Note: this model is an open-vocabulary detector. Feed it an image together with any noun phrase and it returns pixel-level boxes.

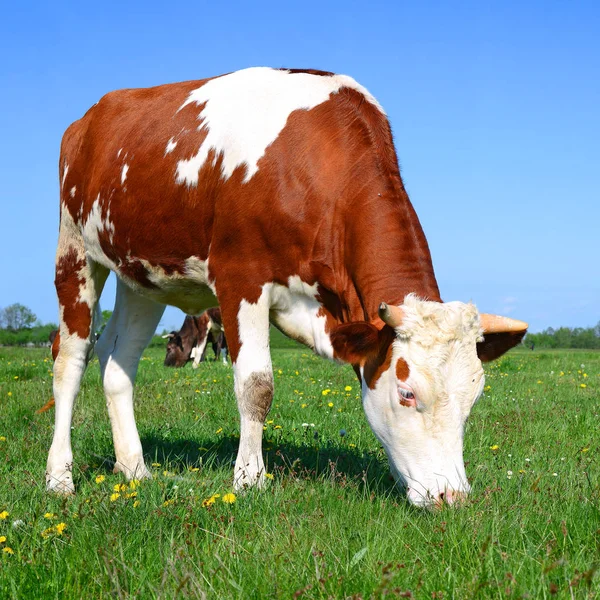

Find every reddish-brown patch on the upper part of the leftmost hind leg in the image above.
[53,247,92,346]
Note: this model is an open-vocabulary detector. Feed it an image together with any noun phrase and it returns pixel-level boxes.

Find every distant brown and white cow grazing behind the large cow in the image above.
[163,308,227,369]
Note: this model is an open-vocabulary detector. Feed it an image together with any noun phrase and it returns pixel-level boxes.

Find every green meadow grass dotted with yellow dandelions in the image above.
[0,346,600,599]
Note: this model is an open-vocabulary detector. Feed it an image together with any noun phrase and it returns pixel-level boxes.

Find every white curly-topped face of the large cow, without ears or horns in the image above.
[362,298,484,506]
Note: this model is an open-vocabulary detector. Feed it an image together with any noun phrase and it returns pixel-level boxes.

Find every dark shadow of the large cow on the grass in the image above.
[133,435,403,500]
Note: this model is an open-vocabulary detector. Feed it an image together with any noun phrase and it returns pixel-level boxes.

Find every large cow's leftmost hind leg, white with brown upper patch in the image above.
[46,230,108,494]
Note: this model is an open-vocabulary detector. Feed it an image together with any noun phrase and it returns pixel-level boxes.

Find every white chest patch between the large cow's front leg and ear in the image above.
[271,275,333,360]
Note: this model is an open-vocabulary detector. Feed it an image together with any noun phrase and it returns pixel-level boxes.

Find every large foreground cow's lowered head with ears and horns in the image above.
[331,295,527,506]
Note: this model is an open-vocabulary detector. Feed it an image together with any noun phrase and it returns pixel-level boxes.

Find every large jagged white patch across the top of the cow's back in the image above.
[176,67,382,186]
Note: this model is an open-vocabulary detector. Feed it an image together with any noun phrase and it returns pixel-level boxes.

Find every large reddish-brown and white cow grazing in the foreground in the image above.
[46,68,527,505]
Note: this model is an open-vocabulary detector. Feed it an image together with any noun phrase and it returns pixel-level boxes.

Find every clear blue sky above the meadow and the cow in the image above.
[0,0,600,331]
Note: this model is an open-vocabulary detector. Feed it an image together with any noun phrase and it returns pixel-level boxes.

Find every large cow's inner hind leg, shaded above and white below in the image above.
[96,281,165,479]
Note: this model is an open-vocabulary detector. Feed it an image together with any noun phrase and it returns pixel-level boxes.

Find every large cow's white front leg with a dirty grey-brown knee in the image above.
[222,294,273,489]
